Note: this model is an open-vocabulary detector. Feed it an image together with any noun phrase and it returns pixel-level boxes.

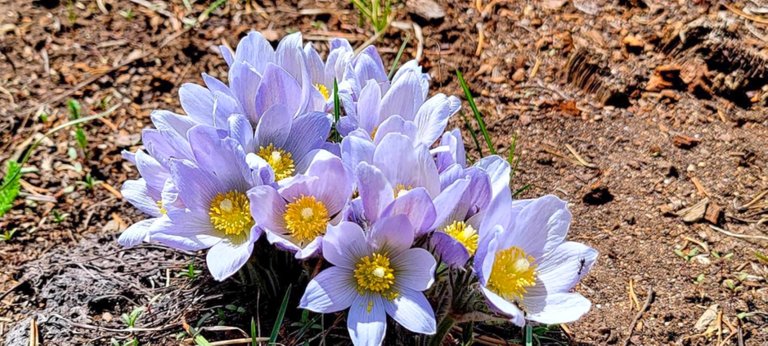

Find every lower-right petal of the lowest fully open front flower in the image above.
[384,289,437,335]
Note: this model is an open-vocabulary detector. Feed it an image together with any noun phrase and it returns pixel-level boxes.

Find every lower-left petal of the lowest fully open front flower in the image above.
[299,267,359,314]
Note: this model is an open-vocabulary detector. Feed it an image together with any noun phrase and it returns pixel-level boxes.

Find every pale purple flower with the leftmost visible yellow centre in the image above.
[150,125,272,280]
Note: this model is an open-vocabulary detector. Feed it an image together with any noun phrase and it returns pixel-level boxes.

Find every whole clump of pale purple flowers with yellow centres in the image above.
[119,32,597,345]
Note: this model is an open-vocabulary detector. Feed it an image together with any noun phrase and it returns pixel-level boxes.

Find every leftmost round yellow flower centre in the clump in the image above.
[208,191,253,236]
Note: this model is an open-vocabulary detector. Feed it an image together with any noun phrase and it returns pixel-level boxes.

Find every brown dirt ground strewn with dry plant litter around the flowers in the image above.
[0,0,768,345]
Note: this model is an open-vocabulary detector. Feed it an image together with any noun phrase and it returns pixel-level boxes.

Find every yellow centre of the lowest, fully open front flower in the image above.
[354,252,399,300]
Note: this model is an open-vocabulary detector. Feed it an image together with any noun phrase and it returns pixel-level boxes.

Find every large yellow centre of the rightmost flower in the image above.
[488,246,536,300]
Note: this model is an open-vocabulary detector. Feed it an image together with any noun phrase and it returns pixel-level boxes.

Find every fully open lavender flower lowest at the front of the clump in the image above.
[299,215,436,345]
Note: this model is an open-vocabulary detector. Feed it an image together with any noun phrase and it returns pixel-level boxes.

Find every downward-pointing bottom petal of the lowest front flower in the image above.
[347,295,387,346]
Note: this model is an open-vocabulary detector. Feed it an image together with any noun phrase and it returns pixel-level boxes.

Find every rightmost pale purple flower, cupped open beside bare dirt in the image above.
[474,194,597,326]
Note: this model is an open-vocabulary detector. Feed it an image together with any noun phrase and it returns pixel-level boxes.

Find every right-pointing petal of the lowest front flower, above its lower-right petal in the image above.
[392,248,437,292]
